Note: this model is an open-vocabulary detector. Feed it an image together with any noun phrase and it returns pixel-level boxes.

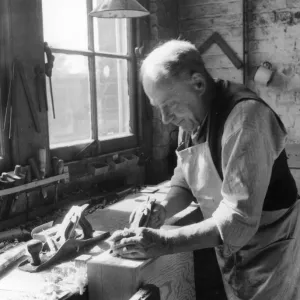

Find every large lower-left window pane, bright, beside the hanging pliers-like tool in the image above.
[47,54,91,146]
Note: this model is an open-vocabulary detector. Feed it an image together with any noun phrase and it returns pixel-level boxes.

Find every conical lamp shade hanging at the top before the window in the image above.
[89,0,150,18]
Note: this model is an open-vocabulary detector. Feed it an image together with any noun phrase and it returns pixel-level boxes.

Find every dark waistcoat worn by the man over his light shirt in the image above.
[182,81,298,211]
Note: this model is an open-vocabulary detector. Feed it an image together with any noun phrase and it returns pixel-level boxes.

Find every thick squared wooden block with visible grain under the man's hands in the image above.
[87,251,196,300]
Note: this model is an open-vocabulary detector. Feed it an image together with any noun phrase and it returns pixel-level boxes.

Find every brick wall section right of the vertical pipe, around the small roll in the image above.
[249,0,300,144]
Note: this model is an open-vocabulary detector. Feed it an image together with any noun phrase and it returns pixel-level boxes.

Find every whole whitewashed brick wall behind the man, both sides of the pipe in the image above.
[178,0,300,189]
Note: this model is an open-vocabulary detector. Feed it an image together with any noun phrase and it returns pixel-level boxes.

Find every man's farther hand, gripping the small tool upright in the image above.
[129,202,167,229]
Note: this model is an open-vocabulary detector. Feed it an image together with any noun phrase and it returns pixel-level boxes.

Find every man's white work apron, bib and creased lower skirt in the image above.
[177,142,300,300]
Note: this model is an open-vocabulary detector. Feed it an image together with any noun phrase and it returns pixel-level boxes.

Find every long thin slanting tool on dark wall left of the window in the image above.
[15,59,41,133]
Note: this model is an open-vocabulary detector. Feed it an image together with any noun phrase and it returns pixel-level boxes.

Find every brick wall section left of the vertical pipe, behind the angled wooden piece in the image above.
[178,0,243,82]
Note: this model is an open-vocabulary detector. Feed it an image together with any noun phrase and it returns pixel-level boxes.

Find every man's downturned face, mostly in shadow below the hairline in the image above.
[143,76,205,132]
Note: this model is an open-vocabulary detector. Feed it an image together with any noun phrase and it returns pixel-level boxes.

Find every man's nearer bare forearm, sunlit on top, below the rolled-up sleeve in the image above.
[167,218,222,253]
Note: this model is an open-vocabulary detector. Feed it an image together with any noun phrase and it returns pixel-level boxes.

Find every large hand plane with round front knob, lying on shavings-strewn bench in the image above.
[19,204,110,273]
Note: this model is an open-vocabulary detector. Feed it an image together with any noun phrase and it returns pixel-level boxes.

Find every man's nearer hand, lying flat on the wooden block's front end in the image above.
[108,227,172,259]
